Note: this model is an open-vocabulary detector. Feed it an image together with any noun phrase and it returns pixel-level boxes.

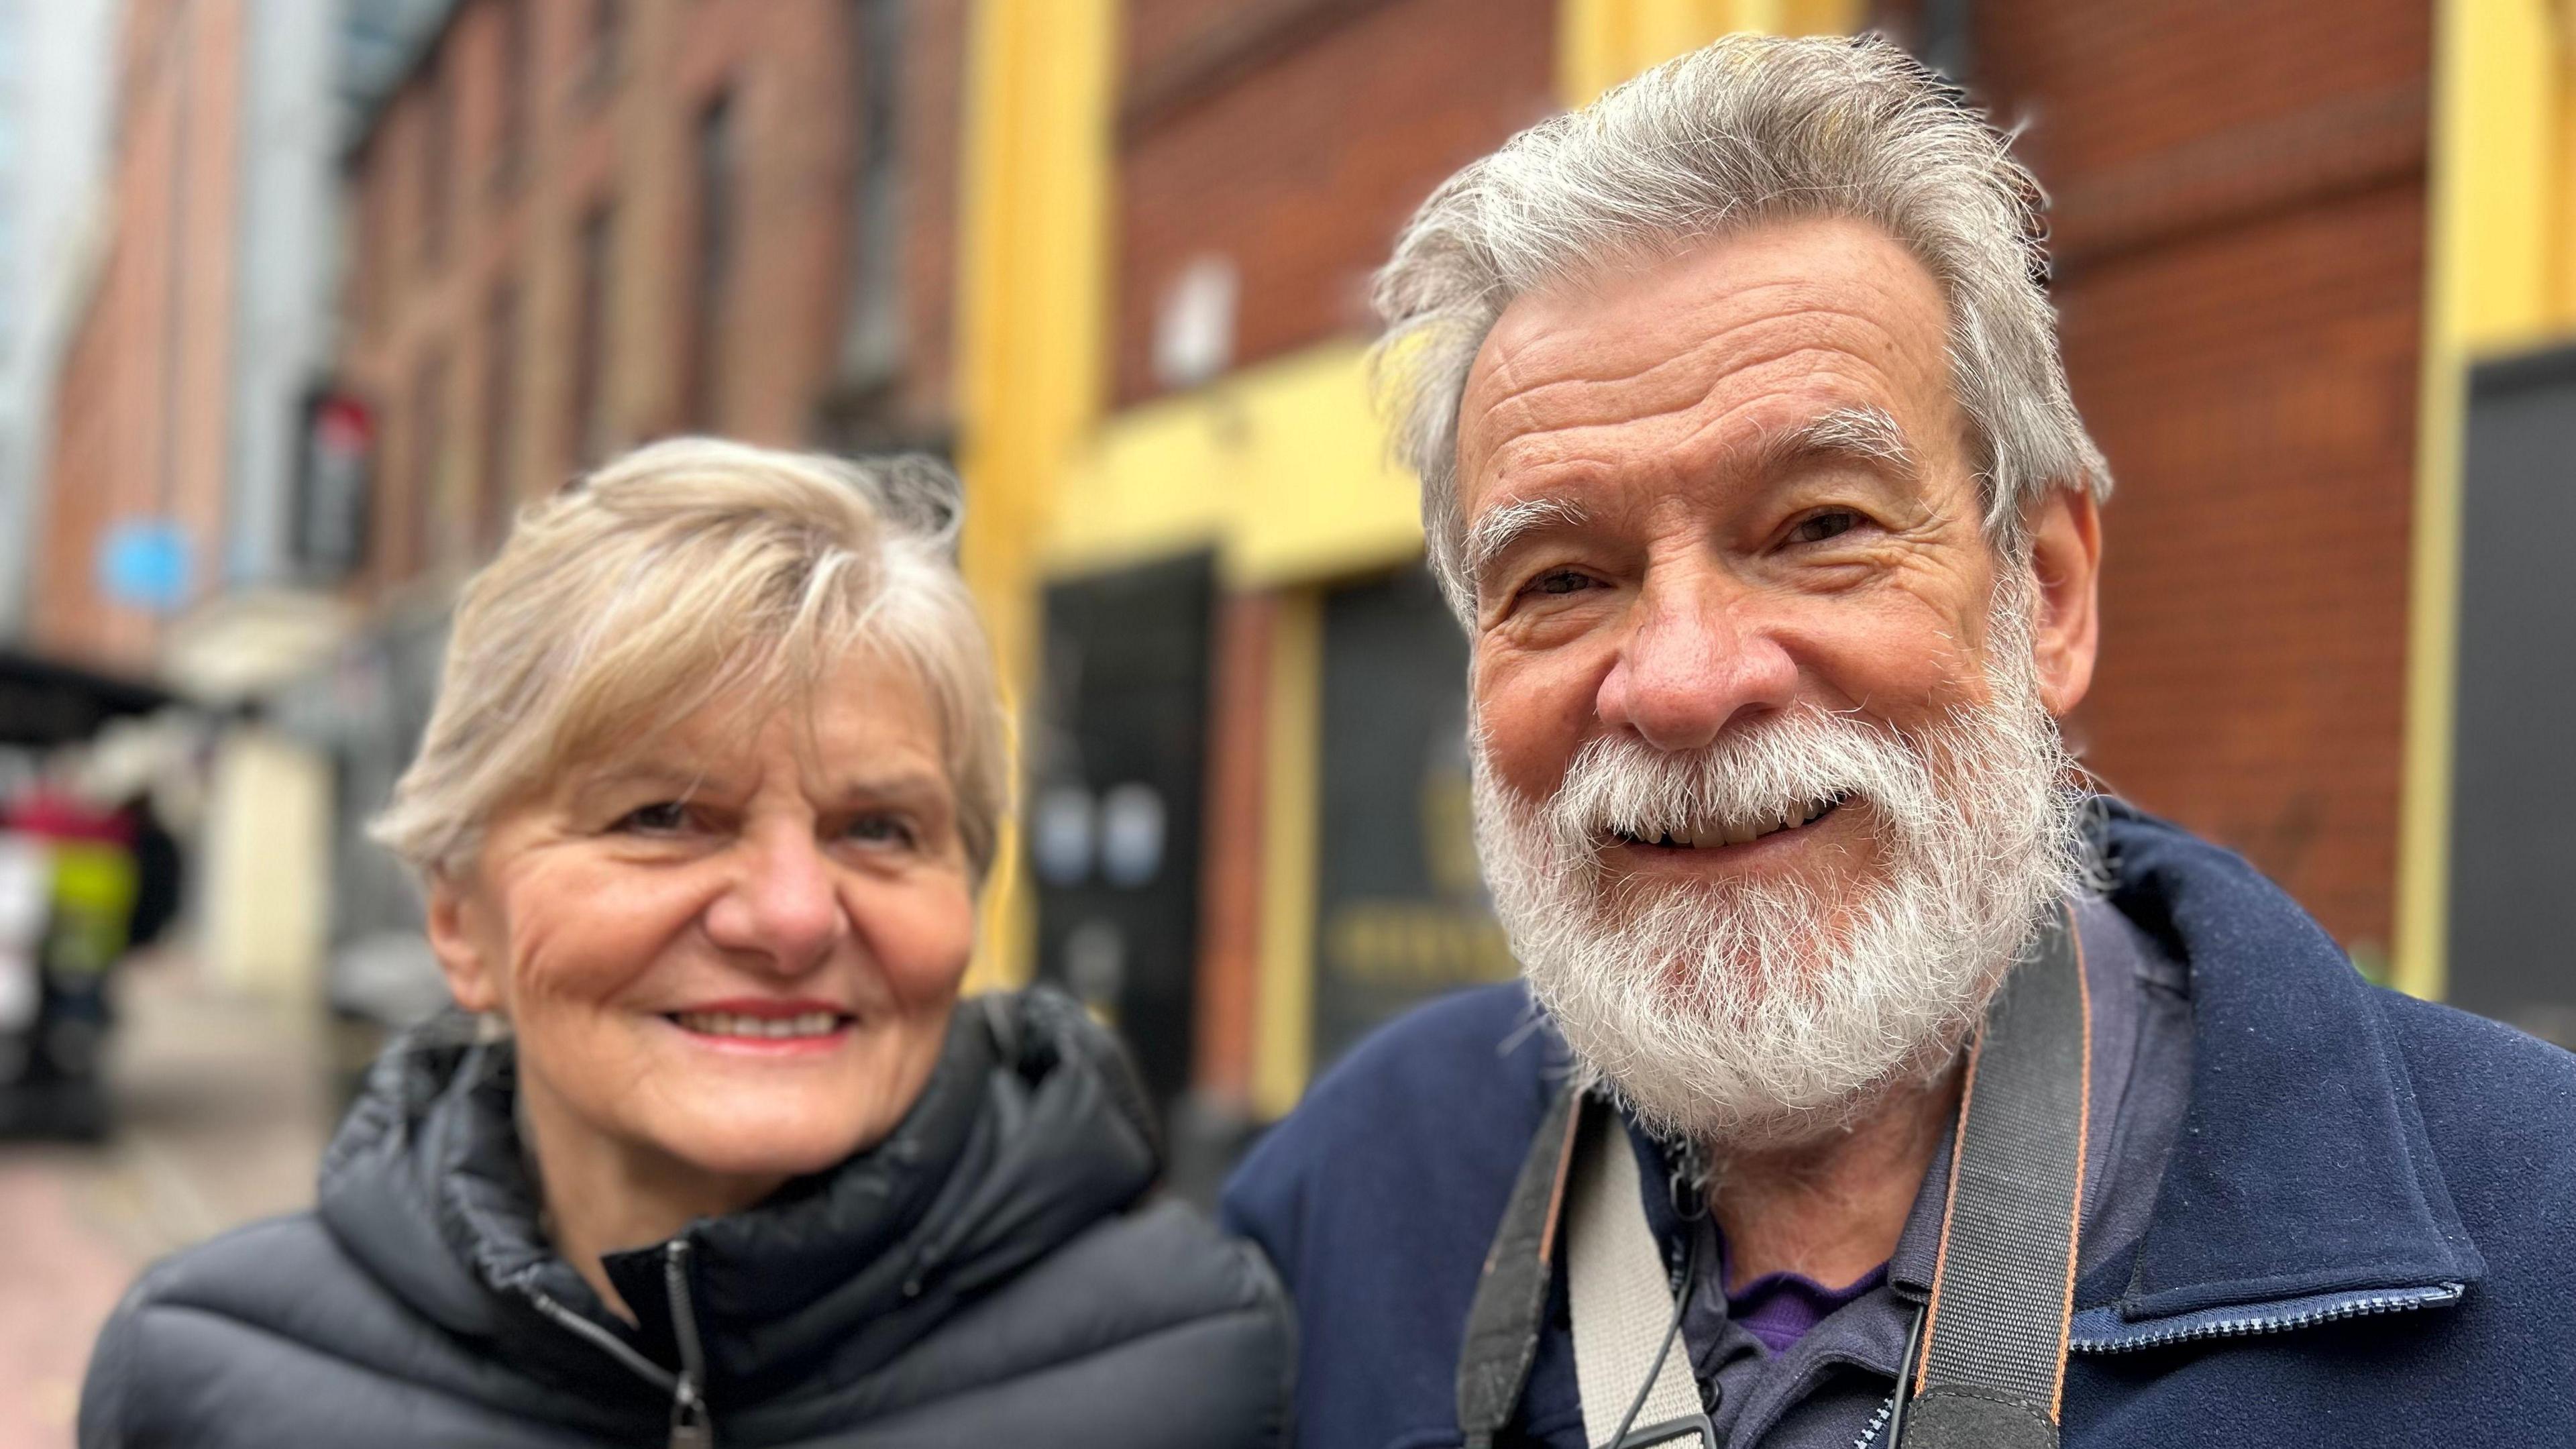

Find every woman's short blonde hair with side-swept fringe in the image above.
[374,438,1010,879]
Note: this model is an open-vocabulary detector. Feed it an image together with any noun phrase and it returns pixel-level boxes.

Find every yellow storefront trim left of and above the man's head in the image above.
[958,0,1865,1116]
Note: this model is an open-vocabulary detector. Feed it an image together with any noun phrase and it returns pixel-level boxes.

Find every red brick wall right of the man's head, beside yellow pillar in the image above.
[1973,0,2429,947]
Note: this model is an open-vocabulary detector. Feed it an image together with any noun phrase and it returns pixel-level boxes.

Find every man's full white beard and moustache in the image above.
[1473,585,2084,1150]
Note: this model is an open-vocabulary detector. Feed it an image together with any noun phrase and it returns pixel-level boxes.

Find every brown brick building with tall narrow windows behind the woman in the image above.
[301,0,969,1021]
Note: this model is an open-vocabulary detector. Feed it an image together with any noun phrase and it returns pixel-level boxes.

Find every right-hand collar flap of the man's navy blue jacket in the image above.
[2076,799,2486,1351]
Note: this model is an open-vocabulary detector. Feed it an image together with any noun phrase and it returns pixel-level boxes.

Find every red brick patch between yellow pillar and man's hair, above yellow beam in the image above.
[1113,0,1556,402]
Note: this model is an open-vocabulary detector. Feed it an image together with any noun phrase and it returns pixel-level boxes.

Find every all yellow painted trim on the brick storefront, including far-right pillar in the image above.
[958,0,2576,1116]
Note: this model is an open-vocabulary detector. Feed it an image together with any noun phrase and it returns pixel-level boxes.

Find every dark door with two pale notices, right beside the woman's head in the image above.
[1028,554,1216,1101]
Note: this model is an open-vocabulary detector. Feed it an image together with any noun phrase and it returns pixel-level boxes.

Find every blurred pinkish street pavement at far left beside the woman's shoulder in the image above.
[0,954,330,1449]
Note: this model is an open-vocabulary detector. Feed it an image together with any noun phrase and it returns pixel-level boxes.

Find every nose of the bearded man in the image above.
[1597,570,1798,750]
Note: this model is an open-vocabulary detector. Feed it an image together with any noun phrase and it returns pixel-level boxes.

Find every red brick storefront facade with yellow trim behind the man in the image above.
[961,0,2576,1134]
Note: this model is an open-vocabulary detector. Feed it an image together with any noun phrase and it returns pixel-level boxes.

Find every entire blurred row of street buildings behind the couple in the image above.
[0,0,2576,1433]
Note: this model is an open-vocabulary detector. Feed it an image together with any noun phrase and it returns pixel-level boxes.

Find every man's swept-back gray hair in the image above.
[1373,36,2110,621]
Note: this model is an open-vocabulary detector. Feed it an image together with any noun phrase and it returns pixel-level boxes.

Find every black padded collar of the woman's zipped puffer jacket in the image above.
[319,990,1159,1397]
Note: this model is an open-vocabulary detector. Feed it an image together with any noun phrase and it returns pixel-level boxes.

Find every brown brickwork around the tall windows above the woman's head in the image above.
[343,0,966,590]
